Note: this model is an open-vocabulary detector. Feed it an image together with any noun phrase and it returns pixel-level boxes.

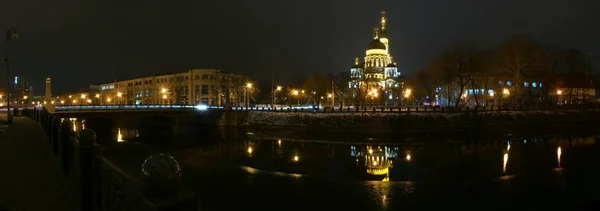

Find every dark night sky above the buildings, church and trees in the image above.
[0,0,600,93]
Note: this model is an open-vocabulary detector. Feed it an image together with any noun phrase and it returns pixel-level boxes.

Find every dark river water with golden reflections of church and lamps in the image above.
[82,120,600,210]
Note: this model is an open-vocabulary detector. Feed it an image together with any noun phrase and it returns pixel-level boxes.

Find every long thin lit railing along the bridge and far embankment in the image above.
[56,105,594,113]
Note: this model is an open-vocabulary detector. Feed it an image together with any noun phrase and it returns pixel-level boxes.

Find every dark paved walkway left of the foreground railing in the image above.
[0,115,67,211]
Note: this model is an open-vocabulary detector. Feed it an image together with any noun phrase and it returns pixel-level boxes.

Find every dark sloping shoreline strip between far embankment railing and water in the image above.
[241,111,600,137]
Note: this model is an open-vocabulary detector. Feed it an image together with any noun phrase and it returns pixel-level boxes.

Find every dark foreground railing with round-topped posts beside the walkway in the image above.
[22,109,198,211]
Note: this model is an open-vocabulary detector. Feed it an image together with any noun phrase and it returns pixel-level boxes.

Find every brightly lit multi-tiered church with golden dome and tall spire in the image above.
[349,12,403,106]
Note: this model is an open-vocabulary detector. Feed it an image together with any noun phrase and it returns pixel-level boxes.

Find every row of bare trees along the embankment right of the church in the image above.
[406,34,592,107]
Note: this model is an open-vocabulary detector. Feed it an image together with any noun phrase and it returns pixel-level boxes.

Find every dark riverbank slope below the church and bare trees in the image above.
[243,110,600,134]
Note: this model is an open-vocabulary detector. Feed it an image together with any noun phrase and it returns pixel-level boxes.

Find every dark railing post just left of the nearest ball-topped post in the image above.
[75,128,97,210]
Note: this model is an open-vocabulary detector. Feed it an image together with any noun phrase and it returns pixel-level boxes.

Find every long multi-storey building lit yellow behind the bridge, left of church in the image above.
[78,69,249,106]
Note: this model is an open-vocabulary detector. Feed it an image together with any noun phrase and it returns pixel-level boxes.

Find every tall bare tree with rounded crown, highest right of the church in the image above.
[496,34,547,104]
